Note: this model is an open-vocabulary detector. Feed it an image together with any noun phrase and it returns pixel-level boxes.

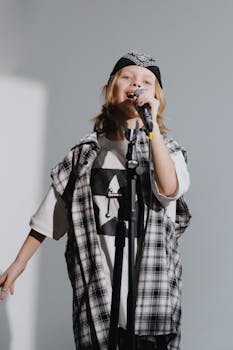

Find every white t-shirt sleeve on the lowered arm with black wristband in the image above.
[29,185,68,240]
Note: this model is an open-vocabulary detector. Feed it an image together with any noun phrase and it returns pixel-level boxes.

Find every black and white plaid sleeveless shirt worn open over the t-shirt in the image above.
[51,131,191,350]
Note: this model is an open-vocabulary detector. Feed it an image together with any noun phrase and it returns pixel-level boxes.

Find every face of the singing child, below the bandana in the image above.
[113,65,156,104]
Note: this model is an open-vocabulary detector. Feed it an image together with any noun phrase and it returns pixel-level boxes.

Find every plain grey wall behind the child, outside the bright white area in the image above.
[0,0,233,350]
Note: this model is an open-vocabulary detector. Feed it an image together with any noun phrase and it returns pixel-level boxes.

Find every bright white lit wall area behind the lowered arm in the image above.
[0,76,47,350]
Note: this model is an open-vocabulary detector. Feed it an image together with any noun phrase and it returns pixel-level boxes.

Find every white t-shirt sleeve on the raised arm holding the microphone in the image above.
[152,151,190,207]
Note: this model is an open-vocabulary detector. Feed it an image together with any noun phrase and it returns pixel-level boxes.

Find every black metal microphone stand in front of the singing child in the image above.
[108,122,139,350]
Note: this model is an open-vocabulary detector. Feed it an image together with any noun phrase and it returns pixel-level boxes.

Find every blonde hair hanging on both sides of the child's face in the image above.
[93,70,168,134]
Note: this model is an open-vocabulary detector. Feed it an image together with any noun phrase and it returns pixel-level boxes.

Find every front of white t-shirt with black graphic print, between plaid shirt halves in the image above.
[91,135,144,328]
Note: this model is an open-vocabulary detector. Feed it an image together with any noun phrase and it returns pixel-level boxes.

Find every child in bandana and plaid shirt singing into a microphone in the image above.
[0,51,191,350]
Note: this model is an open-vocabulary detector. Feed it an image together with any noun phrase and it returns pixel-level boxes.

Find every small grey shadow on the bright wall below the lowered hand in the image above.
[0,302,11,350]
